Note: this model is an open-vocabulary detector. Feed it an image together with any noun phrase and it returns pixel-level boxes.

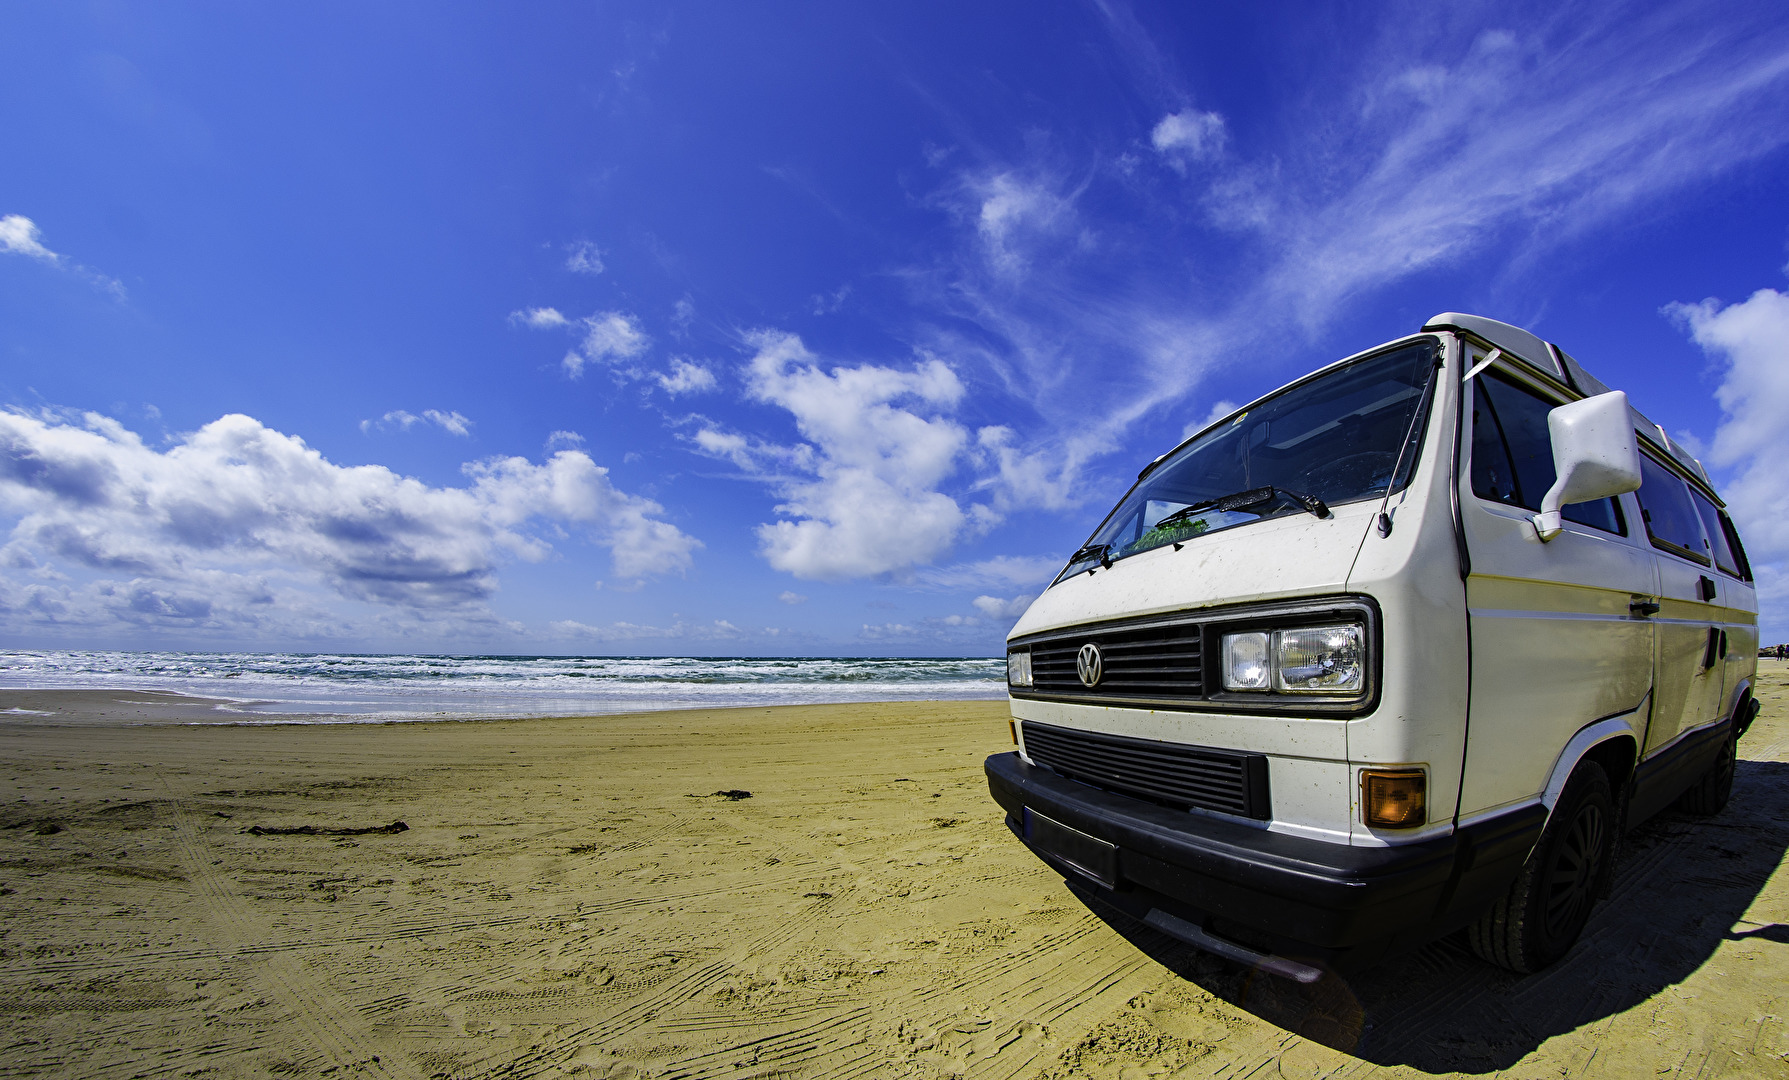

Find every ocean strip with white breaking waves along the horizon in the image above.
[0,649,1005,724]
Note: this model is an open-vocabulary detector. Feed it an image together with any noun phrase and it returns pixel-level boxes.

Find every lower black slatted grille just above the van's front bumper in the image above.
[1020,721,1270,821]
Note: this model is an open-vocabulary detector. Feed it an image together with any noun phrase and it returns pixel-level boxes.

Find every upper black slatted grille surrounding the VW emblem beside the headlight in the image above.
[1030,622,1204,697]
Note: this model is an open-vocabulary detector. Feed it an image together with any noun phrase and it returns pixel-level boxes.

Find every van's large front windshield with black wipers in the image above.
[1057,338,1438,581]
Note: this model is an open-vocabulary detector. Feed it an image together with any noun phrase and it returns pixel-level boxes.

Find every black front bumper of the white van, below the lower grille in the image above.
[986,753,1546,957]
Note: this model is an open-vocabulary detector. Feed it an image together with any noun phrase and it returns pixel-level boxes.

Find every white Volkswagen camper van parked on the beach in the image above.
[986,313,1759,982]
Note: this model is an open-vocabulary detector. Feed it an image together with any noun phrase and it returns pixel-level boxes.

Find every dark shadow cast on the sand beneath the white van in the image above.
[1075,760,1789,1073]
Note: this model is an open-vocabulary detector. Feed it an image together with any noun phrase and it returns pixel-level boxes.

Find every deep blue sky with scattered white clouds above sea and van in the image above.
[0,2,1789,654]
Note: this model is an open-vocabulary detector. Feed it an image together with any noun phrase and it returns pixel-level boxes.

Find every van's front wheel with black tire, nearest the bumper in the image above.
[1467,762,1615,975]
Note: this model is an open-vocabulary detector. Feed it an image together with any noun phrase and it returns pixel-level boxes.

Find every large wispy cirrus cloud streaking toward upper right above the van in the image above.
[911,4,1789,506]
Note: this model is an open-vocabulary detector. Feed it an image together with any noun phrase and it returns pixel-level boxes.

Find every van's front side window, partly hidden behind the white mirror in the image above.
[1472,372,1628,533]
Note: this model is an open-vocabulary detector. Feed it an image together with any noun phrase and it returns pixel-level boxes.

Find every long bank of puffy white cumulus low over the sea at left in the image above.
[0,411,699,629]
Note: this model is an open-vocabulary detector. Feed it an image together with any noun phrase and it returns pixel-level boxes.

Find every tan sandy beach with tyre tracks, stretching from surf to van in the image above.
[0,675,1789,1080]
